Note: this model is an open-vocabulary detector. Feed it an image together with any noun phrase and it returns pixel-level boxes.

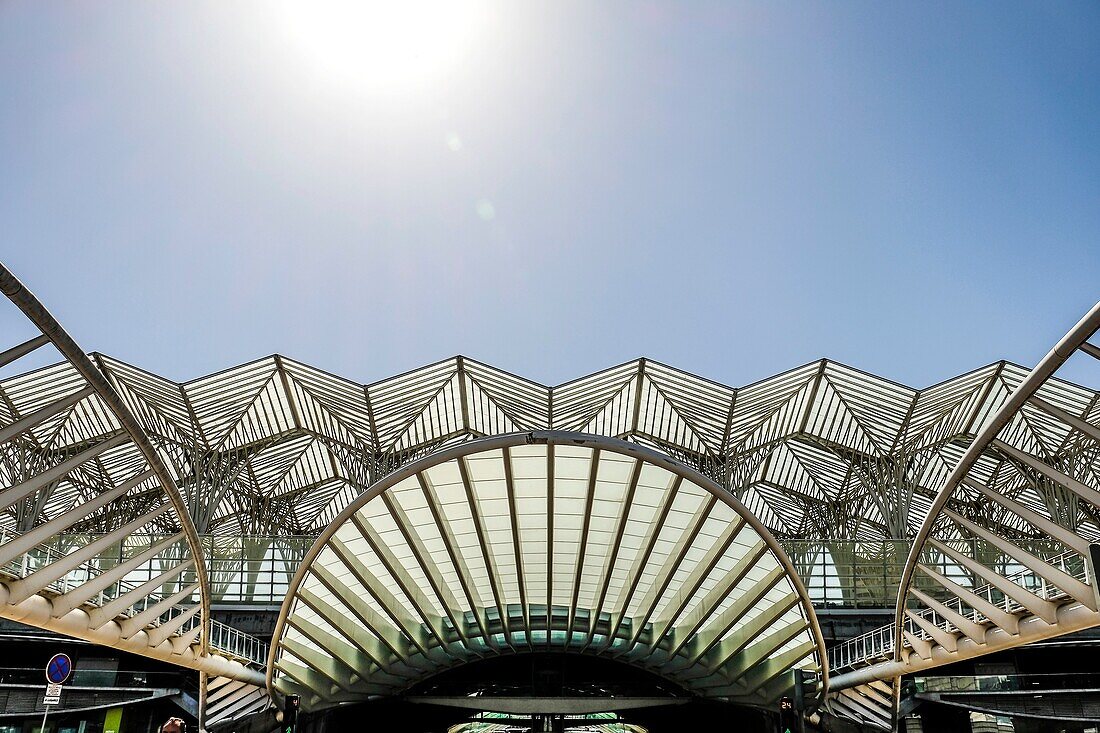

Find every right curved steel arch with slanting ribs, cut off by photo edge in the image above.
[828,304,1100,729]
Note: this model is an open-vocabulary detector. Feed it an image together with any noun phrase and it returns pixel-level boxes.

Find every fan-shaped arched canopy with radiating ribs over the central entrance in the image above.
[268,431,824,710]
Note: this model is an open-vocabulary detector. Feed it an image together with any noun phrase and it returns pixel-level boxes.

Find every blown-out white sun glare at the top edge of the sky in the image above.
[282,0,488,91]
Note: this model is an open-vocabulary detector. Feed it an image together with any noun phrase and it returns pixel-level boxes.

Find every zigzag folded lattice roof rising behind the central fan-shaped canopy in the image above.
[0,354,1097,540]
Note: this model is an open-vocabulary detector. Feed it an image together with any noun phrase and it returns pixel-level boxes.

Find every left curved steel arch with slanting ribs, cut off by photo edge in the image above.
[0,266,262,681]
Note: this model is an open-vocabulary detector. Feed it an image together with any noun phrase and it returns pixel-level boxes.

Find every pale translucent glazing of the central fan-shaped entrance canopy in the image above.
[277,434,817,703]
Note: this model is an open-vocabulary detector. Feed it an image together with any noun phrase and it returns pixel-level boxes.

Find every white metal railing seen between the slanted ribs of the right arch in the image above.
[828,550,1088,671]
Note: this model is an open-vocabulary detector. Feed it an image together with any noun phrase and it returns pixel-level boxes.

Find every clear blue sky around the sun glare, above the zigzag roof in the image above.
[0,0,1100,386]
